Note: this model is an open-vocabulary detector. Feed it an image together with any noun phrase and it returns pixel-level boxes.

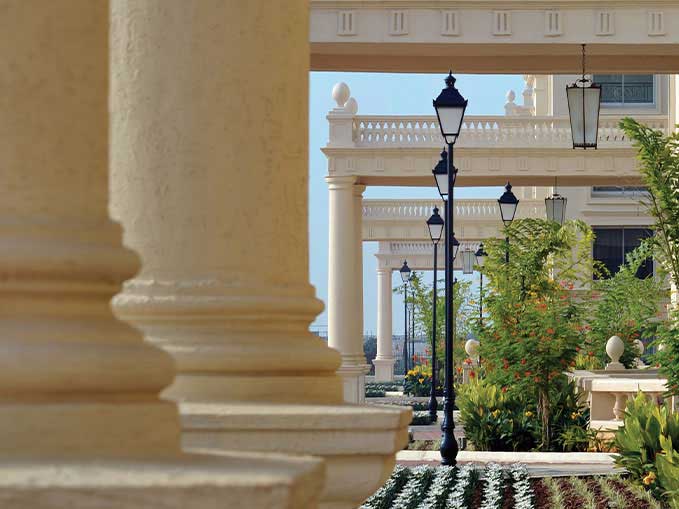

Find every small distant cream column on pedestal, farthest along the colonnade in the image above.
[373,267,396,382]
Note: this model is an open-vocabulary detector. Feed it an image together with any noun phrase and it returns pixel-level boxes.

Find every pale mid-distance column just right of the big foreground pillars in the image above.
[326,177,366,403]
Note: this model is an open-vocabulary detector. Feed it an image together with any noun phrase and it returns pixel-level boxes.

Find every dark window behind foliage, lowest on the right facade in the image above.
[593,227,653,279]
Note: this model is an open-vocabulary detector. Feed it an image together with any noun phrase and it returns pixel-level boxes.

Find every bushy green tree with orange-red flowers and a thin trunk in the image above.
[476,219,593,449]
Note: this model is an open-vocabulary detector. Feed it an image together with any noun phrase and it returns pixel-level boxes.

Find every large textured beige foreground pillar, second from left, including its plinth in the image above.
[111,0,408,508]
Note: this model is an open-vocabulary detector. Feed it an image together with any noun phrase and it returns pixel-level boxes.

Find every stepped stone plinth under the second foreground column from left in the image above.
[179,403,412,509]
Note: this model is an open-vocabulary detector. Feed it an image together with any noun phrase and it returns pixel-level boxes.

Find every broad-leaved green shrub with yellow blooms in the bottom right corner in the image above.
[614,392,679,508]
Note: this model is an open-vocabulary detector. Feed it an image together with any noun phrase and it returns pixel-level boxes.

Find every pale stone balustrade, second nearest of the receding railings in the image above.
[363,199,545,221]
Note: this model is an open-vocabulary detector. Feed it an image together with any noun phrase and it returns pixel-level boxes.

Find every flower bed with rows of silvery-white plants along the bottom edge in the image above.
[361,464,662,509]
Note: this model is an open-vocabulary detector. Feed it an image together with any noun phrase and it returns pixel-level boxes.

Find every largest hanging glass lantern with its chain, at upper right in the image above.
[566,44,601,149]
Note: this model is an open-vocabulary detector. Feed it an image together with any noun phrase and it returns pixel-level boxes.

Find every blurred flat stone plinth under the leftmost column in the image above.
[0,452,324,509]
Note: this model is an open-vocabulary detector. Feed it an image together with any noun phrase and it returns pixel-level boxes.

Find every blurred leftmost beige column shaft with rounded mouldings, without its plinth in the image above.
[0,0,179,459]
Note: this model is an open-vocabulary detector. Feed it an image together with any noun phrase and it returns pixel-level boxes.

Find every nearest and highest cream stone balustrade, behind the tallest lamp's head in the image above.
[352,115,668,148]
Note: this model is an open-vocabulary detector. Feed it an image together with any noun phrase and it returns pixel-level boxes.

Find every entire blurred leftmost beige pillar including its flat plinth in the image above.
[0,0,323,509]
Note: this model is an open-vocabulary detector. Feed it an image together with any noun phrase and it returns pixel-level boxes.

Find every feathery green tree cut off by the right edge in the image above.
[620,118,679,395]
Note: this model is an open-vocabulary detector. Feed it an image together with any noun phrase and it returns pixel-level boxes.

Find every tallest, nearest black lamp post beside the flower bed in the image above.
[433,72,467,465]
